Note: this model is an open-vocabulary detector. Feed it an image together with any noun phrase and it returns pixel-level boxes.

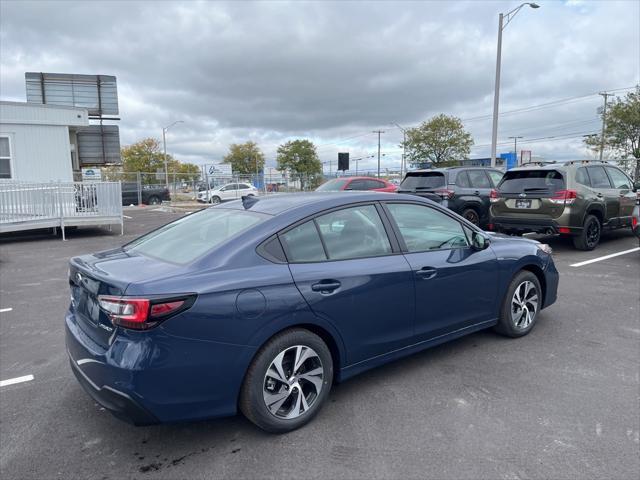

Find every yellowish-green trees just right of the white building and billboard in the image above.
[120,138,200,183]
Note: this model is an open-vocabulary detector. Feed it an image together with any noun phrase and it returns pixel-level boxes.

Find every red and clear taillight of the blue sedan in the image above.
[98,295,195,330]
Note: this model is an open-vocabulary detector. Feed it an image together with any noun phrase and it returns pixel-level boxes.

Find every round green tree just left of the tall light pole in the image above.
[400,114,473,166]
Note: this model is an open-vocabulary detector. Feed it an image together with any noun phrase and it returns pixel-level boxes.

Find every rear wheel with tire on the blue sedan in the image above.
[239,328,333,433]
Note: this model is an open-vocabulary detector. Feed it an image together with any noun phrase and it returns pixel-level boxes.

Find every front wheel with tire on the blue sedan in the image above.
[494,270,542,338]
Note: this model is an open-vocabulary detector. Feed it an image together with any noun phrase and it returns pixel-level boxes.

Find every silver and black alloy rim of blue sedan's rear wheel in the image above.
[262,345,324,419]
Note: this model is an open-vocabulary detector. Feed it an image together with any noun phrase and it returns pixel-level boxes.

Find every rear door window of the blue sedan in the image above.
[316,205,391,260]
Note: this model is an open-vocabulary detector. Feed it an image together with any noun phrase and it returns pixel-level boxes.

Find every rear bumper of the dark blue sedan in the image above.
[65,309,255,425]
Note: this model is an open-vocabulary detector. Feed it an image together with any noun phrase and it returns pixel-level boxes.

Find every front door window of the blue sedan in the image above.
[387,203,469,252]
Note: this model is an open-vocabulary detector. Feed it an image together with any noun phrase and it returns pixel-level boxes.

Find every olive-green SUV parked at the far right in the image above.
[490,160,636,250]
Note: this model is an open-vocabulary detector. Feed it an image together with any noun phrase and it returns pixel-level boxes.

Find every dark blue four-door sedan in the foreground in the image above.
[65,192,558,432]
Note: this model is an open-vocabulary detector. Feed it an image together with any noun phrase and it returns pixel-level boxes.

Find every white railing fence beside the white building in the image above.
[0,182,124,239]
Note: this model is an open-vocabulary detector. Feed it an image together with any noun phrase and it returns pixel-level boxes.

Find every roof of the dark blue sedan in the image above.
[218,191,421,215]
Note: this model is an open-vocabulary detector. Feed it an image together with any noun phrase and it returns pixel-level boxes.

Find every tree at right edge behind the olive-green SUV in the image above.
[584,89,640,182]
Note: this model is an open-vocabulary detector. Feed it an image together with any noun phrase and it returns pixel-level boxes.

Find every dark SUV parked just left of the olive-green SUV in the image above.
[398,167,503,225]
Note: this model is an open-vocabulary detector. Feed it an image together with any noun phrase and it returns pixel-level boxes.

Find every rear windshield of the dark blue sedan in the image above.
[124,207,269,265]
